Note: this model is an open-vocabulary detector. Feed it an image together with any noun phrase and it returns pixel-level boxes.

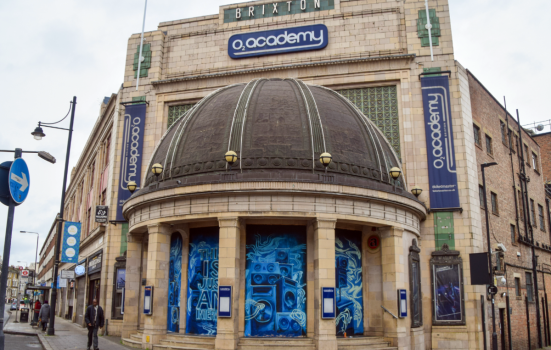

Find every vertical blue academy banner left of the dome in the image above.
[116,103,146,221]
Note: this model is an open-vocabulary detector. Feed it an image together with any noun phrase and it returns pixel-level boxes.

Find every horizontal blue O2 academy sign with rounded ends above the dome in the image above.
[228,24,329,58]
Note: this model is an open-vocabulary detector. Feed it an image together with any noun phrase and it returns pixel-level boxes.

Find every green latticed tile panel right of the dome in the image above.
[337,85,401,158]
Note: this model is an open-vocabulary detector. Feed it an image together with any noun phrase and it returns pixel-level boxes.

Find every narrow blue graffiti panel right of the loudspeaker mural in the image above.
[335,229,364,337]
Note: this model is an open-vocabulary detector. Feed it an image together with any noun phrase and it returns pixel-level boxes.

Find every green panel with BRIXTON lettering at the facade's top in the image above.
[224,0,335,23]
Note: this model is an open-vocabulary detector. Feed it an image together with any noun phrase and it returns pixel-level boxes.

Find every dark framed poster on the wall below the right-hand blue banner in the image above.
[433,264,463,321]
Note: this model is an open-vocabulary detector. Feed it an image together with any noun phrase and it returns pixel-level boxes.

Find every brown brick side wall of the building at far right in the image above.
[469,72,551,349]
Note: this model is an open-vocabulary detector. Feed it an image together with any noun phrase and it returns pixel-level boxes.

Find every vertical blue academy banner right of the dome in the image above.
[421,76,460,209]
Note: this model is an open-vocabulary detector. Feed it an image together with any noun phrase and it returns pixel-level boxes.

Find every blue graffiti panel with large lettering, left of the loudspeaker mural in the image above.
[186,227,220,336]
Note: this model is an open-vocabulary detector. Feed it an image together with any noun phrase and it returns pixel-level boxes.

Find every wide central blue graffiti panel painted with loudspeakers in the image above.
[245,225,306,337]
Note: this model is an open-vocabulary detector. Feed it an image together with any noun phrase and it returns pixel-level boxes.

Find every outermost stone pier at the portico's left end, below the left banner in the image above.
[122,233,143,338]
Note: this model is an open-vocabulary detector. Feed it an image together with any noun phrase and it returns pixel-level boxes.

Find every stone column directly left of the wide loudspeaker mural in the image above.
[215,217,241,350]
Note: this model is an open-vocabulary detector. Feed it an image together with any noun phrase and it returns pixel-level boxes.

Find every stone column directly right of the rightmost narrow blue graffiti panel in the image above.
[379,226,411,349]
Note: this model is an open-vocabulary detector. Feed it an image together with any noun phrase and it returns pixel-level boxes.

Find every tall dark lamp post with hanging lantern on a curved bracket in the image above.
[31,96,77,335]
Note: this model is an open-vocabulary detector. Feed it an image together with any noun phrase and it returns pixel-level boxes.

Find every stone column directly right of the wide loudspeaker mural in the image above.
[313,218,337,350]
